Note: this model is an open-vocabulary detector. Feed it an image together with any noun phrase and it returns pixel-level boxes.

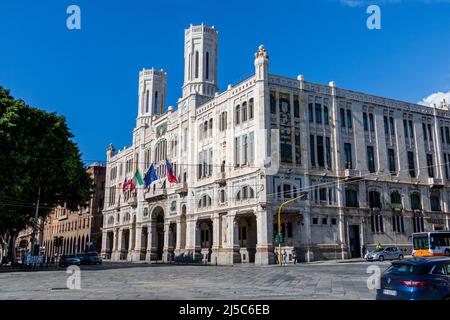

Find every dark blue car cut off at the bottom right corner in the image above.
[377,257,450,300]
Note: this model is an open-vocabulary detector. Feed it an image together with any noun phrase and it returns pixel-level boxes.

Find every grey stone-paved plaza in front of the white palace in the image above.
[0,262,390,300]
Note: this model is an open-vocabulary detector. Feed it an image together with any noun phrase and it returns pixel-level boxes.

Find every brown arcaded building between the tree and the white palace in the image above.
[41,164,106,257]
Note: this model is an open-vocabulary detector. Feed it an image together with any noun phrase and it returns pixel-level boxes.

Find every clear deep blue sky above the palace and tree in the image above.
[0,0,450,164]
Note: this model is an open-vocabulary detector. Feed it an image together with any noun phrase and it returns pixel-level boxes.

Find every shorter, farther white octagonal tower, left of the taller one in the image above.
[138,68,167,118]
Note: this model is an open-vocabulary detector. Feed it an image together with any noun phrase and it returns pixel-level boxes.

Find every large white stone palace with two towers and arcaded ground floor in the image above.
[102,24,450,264]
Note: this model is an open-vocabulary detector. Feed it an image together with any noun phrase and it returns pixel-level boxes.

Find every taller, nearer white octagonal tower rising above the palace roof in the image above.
[183,23,218,98]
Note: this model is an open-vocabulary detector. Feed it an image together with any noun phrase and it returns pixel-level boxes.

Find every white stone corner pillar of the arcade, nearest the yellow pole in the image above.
[255,210,273,264]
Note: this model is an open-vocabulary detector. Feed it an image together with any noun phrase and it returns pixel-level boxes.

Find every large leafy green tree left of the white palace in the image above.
[0,86,93,262]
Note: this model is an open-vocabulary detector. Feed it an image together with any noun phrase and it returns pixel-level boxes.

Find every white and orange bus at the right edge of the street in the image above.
[412,231,450,257]
